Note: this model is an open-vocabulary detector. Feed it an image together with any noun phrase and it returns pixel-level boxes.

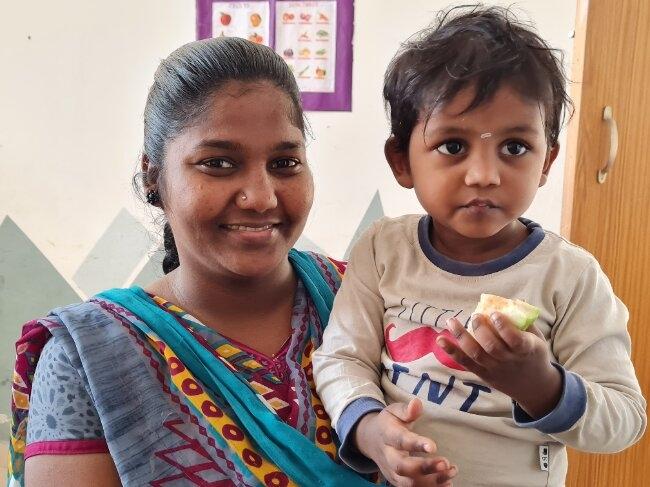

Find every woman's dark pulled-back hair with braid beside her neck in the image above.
[138,37,305,274]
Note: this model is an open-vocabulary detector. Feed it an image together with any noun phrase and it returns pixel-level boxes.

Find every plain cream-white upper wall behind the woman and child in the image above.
[0,0,575,282]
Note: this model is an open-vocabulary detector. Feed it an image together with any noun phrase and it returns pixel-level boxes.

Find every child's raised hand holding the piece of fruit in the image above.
[437,313,562,419]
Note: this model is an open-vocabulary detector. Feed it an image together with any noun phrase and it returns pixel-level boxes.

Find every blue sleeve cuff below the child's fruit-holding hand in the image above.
[512,364,587,434]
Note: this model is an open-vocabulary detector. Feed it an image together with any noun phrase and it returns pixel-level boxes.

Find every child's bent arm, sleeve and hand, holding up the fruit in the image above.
[441,258,647,453]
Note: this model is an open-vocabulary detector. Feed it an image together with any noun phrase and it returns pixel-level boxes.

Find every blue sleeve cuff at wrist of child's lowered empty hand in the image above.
[336,397,386,473]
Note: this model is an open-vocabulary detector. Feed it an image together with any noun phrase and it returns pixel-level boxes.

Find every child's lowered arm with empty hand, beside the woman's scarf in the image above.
[313,223,455,485]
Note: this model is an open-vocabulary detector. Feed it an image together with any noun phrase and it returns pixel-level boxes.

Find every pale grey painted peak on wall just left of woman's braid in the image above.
[74,209,152,296]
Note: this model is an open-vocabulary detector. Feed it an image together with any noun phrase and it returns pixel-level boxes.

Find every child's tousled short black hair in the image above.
[384,5,573,151]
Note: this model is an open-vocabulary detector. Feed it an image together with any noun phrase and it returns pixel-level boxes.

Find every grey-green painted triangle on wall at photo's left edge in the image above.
[0,216,80,440]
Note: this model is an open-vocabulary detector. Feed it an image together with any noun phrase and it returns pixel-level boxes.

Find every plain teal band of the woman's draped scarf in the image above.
[99,249,374,487]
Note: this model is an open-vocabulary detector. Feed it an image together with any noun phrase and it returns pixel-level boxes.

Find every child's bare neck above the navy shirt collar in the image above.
[429,220,529,264]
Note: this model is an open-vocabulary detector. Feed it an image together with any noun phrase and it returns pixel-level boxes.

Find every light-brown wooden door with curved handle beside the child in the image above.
[562,0,650,487]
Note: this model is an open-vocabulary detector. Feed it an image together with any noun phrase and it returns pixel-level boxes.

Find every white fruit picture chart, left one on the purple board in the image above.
[212,1,271,46]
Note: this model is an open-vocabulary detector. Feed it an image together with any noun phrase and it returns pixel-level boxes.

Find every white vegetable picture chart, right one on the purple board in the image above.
[275,1,336,93]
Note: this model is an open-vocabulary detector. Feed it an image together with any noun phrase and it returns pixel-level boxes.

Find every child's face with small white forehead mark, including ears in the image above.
[386,86,558,243]
